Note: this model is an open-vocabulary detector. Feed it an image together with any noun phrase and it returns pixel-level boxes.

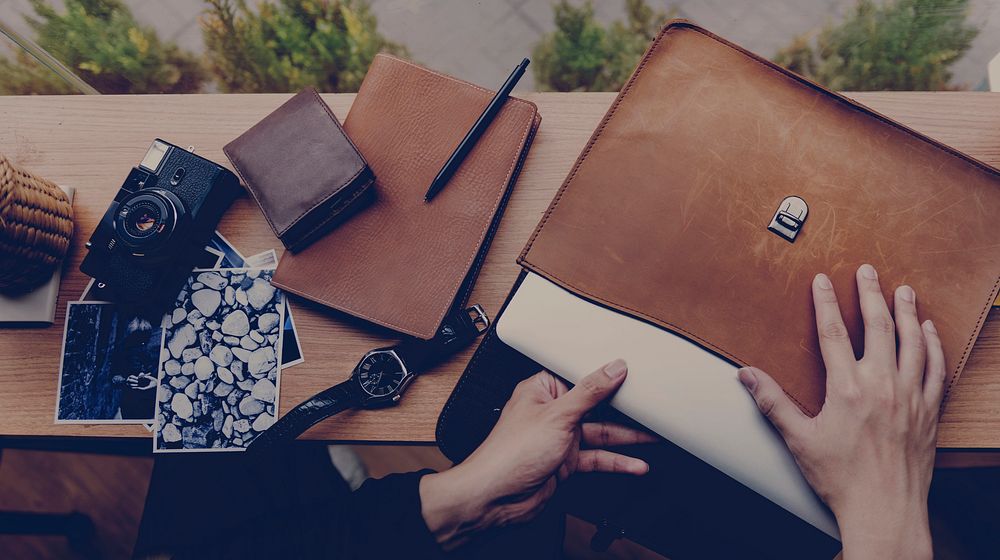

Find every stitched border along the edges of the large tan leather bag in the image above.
[517,21,1000,414]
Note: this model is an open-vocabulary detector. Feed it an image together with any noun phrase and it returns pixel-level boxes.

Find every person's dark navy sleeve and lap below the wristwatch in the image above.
[135,445,441,560]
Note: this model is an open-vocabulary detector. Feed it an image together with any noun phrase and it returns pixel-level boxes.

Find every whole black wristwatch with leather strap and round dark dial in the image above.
[248,305,490,451]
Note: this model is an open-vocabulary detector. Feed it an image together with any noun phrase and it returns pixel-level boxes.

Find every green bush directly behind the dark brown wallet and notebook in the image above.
[202,0,406,92]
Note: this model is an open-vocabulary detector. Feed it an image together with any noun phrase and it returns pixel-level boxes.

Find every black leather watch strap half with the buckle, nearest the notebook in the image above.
[394,305,490,373]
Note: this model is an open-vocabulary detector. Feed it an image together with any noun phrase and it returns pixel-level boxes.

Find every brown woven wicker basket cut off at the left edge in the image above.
[0,154,73,293]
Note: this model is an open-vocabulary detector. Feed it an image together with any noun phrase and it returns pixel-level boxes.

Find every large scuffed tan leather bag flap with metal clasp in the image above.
[519,21,1000,414]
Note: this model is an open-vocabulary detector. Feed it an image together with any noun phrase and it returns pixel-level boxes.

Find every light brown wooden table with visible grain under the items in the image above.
[0,92,1000,448]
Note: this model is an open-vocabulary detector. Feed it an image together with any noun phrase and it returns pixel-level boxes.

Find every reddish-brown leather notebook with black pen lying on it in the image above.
[273,54,541,339]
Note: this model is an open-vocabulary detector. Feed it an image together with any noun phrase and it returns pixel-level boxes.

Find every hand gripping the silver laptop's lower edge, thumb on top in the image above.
[420,360,656,548]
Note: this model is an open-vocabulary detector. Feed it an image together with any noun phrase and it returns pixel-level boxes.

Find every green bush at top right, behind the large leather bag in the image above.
[774,0,979,91]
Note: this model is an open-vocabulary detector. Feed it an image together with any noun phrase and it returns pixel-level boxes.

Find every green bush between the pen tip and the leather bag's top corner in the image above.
[533,0,675,91]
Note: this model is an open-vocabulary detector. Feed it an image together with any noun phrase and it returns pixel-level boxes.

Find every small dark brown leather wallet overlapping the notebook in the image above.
[223,88,375,252]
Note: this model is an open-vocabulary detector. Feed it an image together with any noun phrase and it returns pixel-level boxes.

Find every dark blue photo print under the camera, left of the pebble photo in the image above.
[56,302,163,424]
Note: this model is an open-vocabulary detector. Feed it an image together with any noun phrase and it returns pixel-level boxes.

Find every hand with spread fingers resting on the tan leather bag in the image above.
[739,265,945,560]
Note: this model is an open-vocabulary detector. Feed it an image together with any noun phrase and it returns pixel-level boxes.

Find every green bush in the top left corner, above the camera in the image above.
[0,0,206,95]
